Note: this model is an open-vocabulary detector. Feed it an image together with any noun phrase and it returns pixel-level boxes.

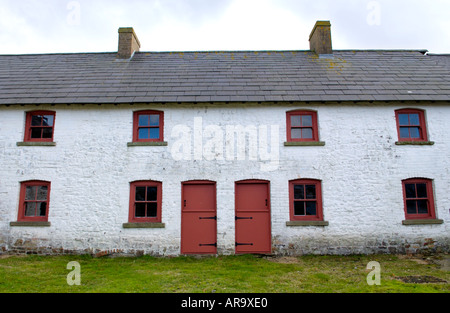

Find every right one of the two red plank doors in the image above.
[235,180,272,253]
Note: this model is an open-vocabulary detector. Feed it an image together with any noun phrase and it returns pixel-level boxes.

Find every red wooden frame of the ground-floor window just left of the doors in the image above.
[128,180,162,223]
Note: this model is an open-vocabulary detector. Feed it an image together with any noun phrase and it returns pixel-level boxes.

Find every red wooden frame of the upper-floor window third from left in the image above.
[286,110,319,142]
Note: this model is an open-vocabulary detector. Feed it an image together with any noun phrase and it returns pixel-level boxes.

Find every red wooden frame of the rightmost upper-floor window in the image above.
[395,109,428,141]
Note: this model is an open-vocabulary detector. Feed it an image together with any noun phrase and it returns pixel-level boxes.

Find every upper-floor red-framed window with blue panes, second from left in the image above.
[133,111,164,142]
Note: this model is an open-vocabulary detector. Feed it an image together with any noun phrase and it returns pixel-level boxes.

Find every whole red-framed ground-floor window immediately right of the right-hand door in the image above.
[289,179,323,221]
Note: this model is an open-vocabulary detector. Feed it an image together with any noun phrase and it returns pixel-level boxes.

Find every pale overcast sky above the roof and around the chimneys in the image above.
[0,0,450,54]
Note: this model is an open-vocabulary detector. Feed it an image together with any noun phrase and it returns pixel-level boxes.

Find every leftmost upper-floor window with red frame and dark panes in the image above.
[24,111,55,141]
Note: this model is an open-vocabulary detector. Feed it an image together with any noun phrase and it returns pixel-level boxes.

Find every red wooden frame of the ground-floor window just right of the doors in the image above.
[289,179,323,221]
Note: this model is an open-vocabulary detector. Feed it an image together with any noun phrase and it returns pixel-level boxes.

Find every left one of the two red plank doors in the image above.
[181,181,217,254]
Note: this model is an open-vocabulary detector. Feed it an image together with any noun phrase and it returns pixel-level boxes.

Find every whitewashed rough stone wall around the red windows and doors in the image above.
[0,103,450,255]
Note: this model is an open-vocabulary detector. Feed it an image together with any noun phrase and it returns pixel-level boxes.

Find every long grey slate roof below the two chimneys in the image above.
[0,50,450,105]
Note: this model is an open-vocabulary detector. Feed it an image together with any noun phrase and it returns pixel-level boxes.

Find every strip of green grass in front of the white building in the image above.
[0,255,450,293]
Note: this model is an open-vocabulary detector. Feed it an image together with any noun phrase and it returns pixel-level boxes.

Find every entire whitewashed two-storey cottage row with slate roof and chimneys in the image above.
[0,22,450,256]
